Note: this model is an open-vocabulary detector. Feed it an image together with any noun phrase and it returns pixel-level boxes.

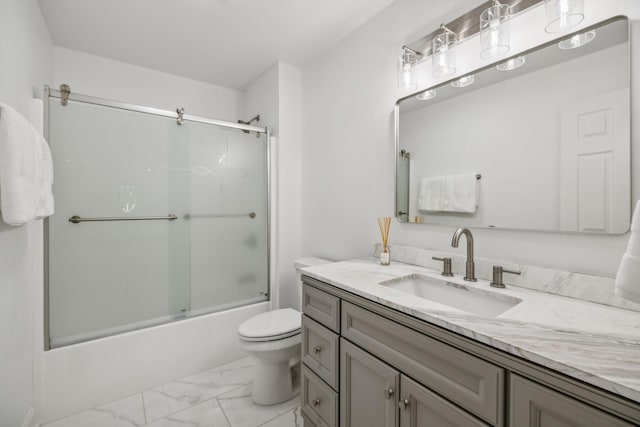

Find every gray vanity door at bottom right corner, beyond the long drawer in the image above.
[509,375,633,427]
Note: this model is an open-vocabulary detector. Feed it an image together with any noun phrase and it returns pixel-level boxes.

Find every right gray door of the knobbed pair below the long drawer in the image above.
[399,375,488,427]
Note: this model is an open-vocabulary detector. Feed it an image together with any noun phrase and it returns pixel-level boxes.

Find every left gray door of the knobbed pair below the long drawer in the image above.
[340,338,400,427]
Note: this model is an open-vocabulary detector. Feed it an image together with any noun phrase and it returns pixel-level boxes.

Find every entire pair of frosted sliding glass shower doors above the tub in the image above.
[45,95,269,347]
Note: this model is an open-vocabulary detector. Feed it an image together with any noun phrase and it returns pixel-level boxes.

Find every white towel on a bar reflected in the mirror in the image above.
[418,174,478,213]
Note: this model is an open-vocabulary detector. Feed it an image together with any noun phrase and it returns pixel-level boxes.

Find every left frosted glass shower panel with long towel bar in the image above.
[48,98,191,347]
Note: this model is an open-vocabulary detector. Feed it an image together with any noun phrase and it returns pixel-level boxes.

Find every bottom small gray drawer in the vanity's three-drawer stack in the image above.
[301,364,338,427]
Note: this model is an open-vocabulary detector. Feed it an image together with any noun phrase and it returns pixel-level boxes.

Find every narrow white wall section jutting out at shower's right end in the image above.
[245,62,301,308]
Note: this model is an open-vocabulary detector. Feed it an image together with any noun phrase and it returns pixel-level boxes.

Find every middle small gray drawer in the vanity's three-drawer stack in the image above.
[302,315,339,389]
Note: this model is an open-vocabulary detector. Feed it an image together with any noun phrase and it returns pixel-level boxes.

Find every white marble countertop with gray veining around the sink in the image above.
[302,258,640,403]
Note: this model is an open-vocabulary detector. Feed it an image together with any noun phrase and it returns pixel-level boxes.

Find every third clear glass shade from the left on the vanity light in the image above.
[480,2,511,59]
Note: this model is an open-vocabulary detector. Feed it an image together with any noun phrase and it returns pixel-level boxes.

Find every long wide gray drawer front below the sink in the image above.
[342,301,504,426]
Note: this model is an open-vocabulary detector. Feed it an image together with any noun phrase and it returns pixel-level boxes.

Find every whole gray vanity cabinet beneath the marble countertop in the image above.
[302,276,640,427]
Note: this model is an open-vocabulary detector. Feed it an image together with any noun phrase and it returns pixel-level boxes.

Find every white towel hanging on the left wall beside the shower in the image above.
[0,104,54,225]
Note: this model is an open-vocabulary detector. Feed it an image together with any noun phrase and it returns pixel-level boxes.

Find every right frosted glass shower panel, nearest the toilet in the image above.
[188,123,269,313]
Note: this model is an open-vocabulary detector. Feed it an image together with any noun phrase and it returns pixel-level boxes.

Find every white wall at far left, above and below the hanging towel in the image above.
[0,0,53,426]
